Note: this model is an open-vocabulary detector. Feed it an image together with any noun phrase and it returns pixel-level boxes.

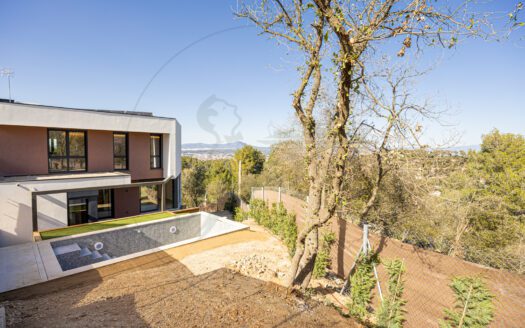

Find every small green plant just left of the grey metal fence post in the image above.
[348,254,379,322]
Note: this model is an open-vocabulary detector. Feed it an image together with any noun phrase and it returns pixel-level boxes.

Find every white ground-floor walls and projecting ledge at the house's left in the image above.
[0,175,131,247]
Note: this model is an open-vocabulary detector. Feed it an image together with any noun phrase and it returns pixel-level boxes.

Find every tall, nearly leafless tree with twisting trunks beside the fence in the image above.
[236,0,521,287]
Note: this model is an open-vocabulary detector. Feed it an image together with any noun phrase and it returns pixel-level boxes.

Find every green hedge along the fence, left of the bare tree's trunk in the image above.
[244,199,297,254]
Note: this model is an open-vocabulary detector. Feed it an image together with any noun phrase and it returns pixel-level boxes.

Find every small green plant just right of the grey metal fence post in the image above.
[376,259,406,328]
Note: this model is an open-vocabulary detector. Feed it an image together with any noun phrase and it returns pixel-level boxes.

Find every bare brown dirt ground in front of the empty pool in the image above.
[0,219,358,327]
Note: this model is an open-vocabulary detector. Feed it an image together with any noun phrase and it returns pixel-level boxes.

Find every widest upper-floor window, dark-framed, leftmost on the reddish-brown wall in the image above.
[47,130,87,173]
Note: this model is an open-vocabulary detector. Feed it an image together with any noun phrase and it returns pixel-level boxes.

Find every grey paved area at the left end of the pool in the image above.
[0,243,48,293]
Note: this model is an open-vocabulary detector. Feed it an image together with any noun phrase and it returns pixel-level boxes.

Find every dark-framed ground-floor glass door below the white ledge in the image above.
[67,189,113,225]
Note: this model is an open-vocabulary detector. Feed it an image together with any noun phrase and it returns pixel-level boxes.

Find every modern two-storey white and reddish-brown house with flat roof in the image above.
[0,100,181,247]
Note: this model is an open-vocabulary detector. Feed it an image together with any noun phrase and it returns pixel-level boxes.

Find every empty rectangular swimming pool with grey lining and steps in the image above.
[49,212,248,272]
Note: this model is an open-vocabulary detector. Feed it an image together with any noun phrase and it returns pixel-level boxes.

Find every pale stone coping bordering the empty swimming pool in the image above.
[36,212,249,281]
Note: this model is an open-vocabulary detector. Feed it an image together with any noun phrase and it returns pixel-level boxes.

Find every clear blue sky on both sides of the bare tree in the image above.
[0,0,525,145]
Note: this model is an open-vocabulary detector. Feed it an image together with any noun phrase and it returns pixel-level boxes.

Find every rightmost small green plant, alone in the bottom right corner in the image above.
[439,277,494,328]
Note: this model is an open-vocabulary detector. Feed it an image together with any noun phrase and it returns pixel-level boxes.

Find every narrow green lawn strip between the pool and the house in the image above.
[40,212,177,240]
